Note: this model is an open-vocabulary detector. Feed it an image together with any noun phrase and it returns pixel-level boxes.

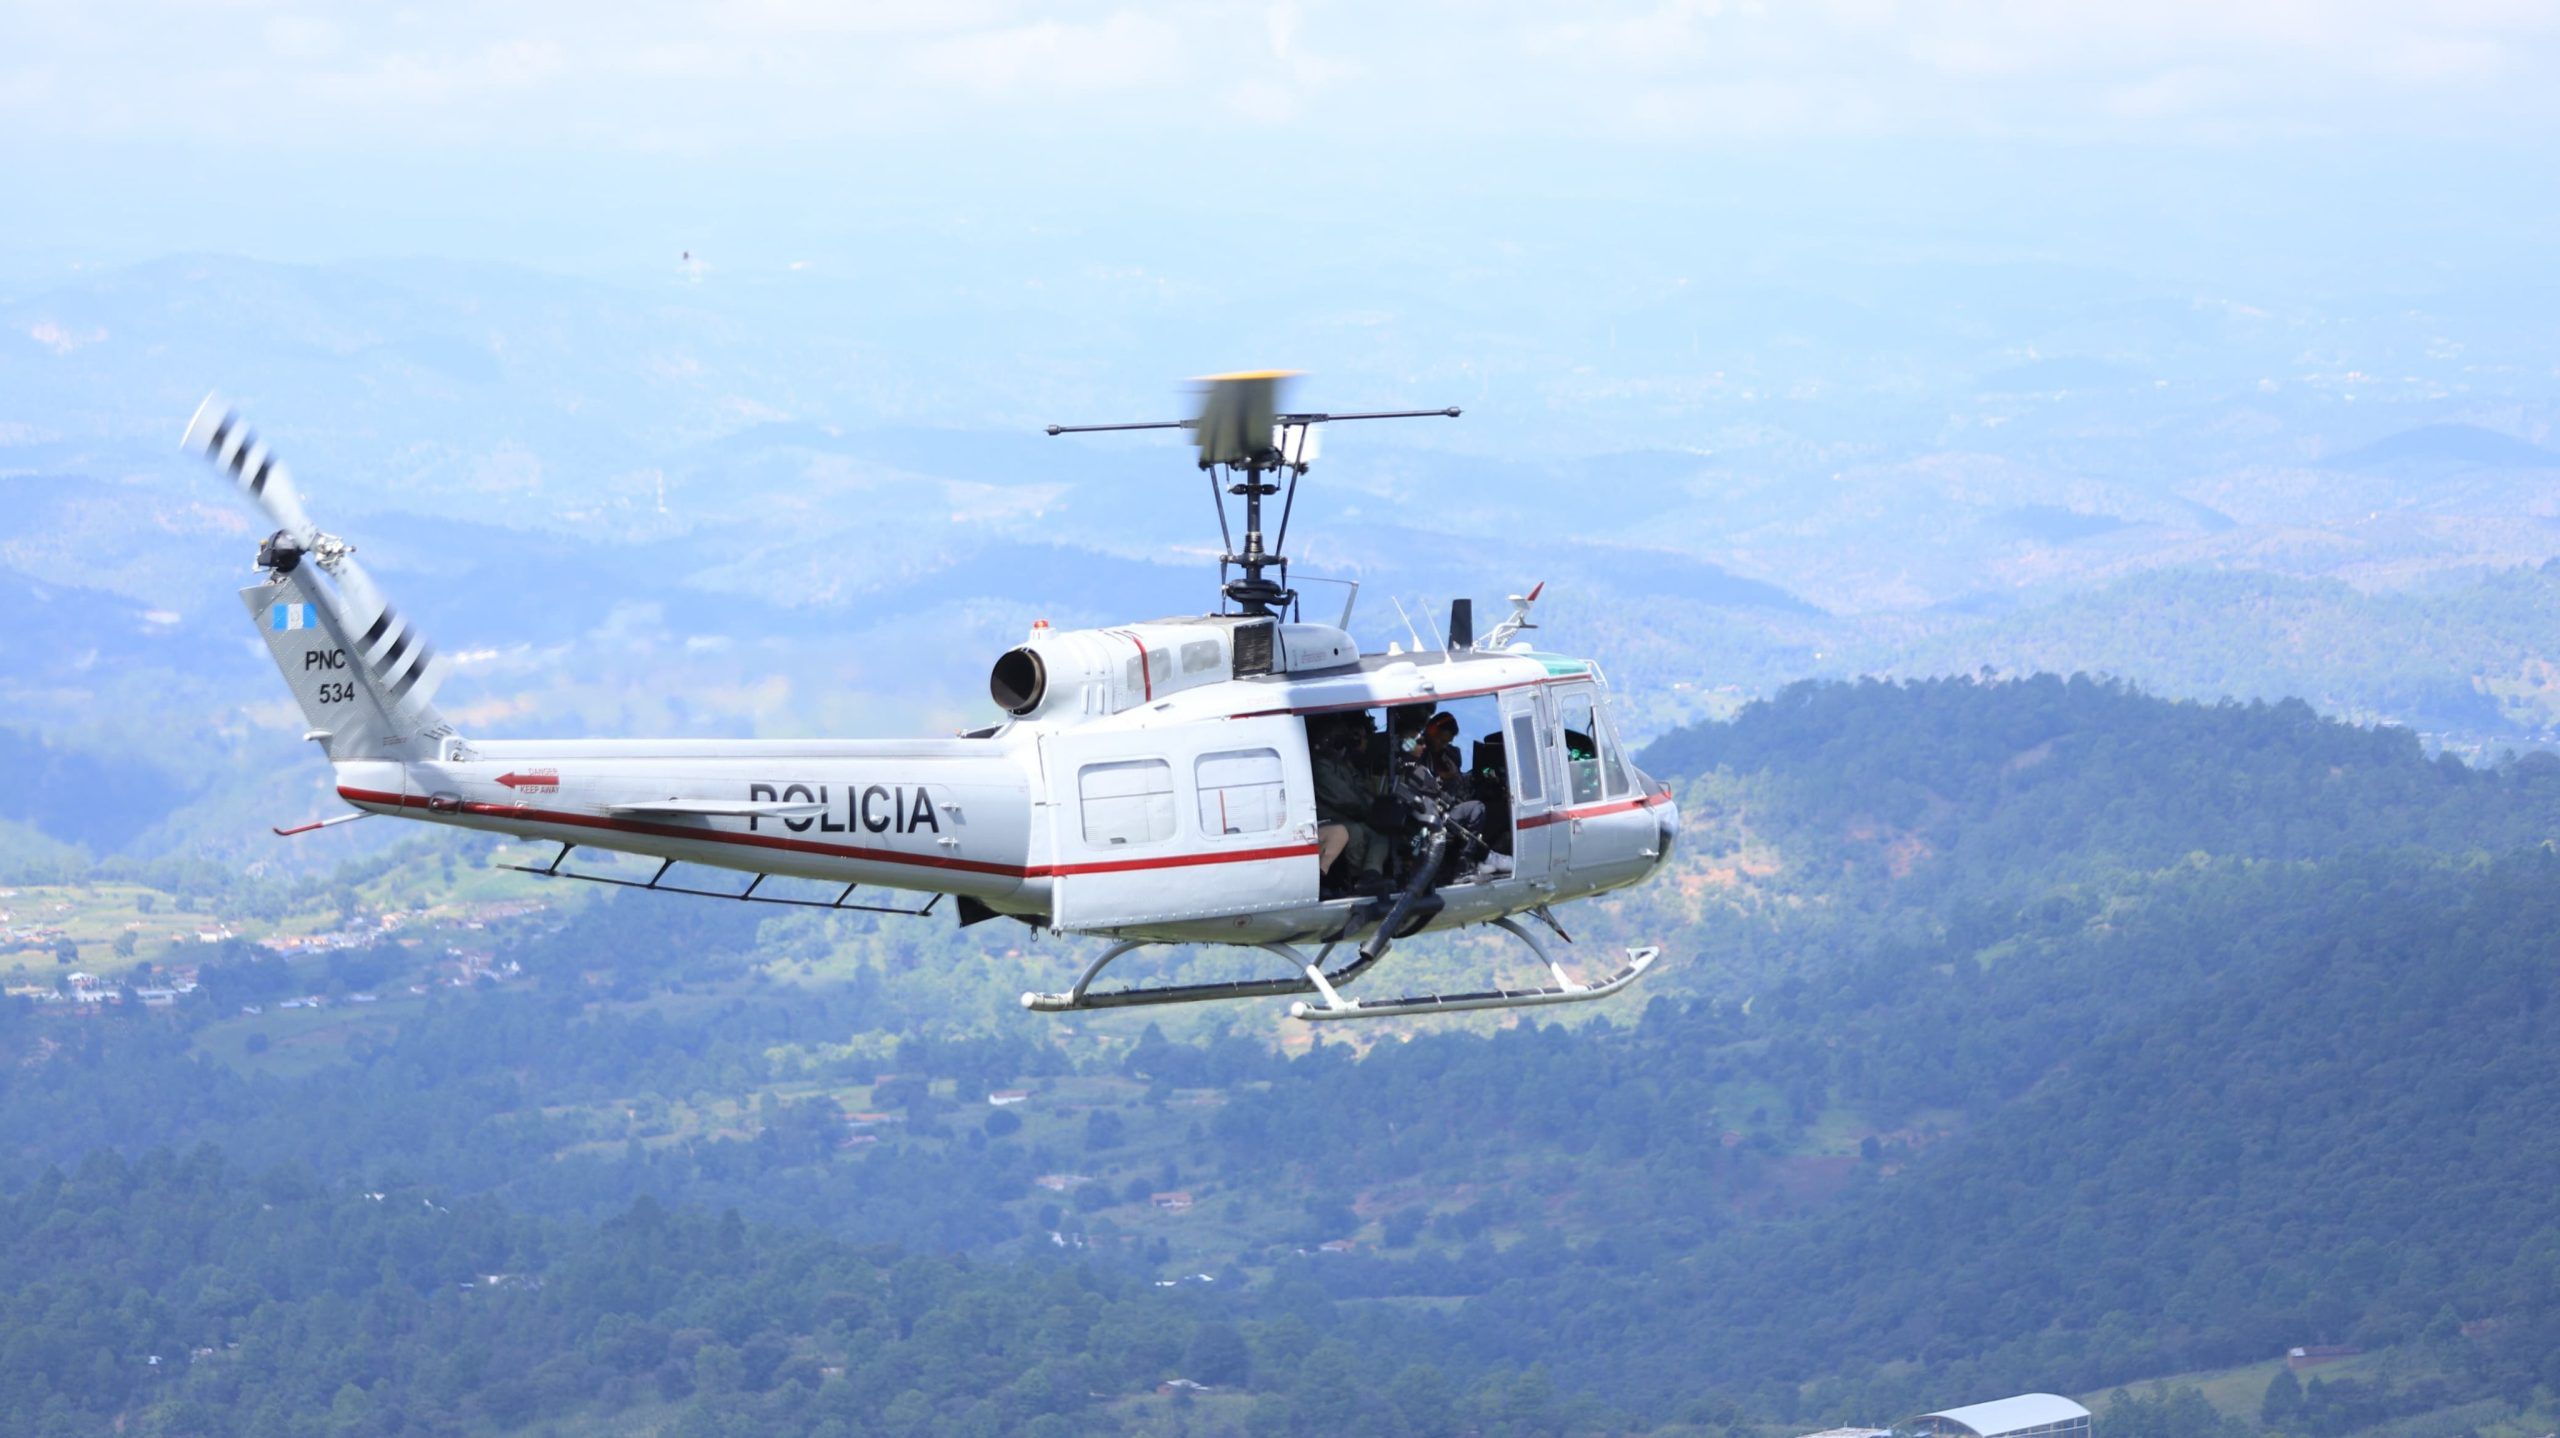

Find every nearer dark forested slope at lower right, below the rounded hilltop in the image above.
[1423,852,2560,1415]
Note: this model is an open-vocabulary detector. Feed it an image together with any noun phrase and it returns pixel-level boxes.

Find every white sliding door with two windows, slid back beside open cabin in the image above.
[1042,714,1316,929]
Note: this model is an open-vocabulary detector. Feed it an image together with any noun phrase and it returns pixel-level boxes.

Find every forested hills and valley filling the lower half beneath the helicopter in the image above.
[0,678,2560,1438]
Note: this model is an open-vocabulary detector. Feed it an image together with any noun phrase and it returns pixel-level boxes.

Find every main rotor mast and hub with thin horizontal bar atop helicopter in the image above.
[1050,368,1459,617]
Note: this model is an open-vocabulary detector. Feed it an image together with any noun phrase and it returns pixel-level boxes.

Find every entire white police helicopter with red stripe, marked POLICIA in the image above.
[184,371,1679,1021]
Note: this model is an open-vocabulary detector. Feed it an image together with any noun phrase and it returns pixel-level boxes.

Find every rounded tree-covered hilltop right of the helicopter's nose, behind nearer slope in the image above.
[1638,676,2560,898]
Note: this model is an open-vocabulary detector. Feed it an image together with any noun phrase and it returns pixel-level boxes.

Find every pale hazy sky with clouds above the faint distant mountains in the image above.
[0,0,2560,279]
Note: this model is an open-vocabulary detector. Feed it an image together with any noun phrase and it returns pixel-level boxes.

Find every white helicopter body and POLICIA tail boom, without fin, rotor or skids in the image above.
[338,637,1679,944]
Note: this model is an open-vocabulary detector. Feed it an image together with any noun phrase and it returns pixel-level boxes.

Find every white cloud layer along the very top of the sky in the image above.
[0,0,2560,154]
